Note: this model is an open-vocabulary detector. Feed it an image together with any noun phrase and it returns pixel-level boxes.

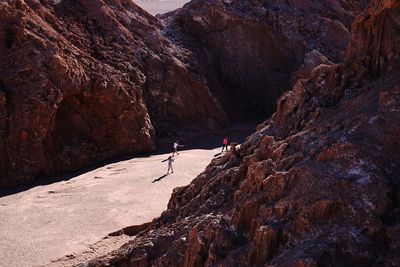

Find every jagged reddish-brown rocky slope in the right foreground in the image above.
[84,0,400,266]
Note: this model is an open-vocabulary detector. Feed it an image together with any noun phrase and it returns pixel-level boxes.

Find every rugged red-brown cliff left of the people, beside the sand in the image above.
[0,0,227,187]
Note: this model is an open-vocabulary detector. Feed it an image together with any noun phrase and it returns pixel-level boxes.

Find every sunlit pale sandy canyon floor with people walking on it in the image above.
[0,148,220,267]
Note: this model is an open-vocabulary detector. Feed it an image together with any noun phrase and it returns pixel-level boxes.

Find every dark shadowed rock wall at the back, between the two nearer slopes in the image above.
[162,0,359,120]
